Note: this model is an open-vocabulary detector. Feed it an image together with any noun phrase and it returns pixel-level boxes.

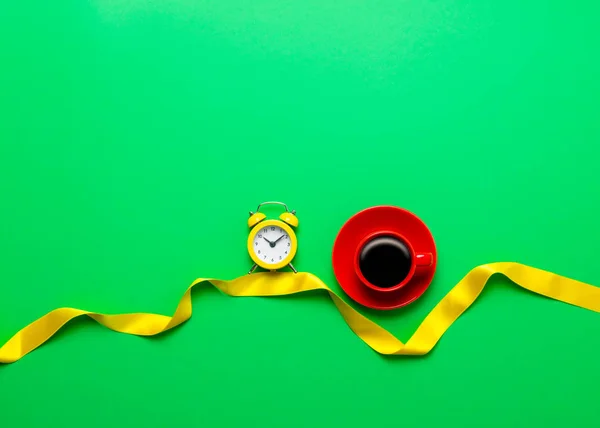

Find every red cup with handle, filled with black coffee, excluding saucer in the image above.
[355,232,432,291]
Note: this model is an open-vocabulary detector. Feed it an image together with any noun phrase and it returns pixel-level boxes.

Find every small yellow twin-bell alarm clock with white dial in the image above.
[248,202,298,273]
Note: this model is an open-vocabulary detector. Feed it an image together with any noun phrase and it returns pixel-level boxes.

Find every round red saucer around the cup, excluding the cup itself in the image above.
[333,206,437,310]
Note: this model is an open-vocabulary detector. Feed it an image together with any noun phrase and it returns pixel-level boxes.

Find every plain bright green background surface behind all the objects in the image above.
[0,0,600,428]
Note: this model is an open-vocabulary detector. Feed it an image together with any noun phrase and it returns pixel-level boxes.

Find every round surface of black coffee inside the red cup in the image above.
[358,236,411,288]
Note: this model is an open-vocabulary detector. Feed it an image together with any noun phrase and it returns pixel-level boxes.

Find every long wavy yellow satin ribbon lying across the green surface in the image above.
[0,263,600,364]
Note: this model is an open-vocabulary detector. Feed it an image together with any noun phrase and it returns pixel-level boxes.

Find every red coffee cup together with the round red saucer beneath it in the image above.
[332,205,437,310]
